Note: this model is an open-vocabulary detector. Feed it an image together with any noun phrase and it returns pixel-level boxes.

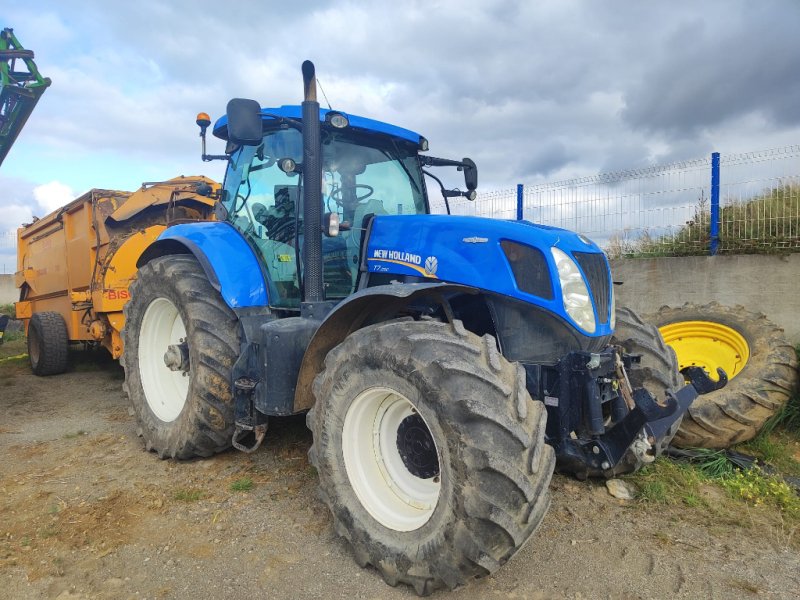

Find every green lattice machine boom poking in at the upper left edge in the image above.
[0,28,51,165]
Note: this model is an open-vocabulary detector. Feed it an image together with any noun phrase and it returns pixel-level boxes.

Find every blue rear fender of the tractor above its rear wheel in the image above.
[158,222,267,308]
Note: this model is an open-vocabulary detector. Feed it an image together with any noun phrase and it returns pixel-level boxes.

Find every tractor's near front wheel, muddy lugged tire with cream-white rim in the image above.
[307,321,555,595]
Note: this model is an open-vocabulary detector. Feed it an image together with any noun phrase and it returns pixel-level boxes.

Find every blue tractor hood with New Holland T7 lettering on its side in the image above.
[367,215,612,337]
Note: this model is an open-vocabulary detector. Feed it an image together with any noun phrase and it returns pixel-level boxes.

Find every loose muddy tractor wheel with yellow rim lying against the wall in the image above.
[651,302,798,448]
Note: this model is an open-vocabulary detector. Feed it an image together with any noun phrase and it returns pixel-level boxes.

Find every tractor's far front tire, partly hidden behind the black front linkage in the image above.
[611,308,684,460]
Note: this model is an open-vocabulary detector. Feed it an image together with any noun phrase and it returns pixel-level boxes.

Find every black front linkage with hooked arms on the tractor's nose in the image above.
[526,346,725,479]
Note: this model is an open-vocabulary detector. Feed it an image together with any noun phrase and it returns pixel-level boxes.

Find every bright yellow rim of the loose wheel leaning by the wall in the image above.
[658,321,750,381]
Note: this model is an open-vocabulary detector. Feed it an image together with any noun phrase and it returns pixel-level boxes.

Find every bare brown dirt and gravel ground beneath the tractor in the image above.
[0,350,800,600]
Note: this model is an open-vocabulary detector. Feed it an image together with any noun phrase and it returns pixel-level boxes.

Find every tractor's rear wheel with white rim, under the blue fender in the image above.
[120,254,239,459]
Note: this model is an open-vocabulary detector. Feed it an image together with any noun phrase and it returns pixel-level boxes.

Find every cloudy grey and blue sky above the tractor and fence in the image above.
[0,0,800,272]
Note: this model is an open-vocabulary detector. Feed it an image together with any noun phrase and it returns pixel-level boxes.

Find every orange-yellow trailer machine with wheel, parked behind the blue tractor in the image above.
[15,177,219,375]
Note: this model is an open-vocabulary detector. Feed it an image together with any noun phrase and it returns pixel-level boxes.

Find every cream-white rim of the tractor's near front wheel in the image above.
[342,388,441,531]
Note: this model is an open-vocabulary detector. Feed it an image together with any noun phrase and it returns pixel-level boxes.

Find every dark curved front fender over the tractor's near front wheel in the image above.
[294,283,479,412]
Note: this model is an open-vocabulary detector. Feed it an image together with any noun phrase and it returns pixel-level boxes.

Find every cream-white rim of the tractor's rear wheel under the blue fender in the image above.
[139,298,190,423]
